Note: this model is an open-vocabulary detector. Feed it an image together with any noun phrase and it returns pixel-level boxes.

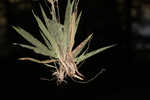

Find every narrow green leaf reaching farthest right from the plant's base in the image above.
[75,45,115,64]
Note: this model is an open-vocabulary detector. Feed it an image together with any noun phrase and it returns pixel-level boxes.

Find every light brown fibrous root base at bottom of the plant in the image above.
[53,53,84,84]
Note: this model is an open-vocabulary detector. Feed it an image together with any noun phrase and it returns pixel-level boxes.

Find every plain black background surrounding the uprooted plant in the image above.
[0,0,150,100]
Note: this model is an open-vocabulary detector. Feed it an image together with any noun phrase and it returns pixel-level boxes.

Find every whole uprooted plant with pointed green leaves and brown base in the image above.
[13,0,114,83]
